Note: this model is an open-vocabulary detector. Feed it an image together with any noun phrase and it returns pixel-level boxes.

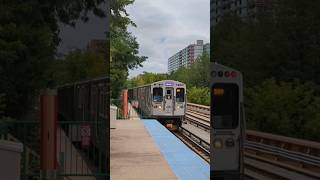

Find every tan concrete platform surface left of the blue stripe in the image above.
[110,117,177,180]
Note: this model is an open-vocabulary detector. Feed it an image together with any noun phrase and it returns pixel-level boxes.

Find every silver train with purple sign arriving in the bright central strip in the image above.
[128,80,187,127]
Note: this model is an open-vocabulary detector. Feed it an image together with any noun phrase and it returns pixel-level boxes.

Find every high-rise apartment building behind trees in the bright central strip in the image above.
[168,40,210,73]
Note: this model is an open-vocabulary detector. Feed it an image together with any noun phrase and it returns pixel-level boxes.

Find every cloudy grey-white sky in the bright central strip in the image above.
[127,0,210,78]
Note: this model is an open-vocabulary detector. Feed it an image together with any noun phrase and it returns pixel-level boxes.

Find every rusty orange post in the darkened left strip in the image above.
[40,89,58,180]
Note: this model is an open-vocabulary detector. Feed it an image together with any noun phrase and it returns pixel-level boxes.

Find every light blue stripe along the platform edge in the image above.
[143,119,210,180]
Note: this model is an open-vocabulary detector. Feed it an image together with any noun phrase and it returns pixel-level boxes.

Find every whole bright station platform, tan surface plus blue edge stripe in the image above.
[110,104,210,180]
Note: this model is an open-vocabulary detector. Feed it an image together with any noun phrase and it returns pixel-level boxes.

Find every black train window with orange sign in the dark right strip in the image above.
[210,83,239,129]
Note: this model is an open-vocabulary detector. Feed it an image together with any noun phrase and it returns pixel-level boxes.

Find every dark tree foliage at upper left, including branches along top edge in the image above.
[0,0,105,118]
